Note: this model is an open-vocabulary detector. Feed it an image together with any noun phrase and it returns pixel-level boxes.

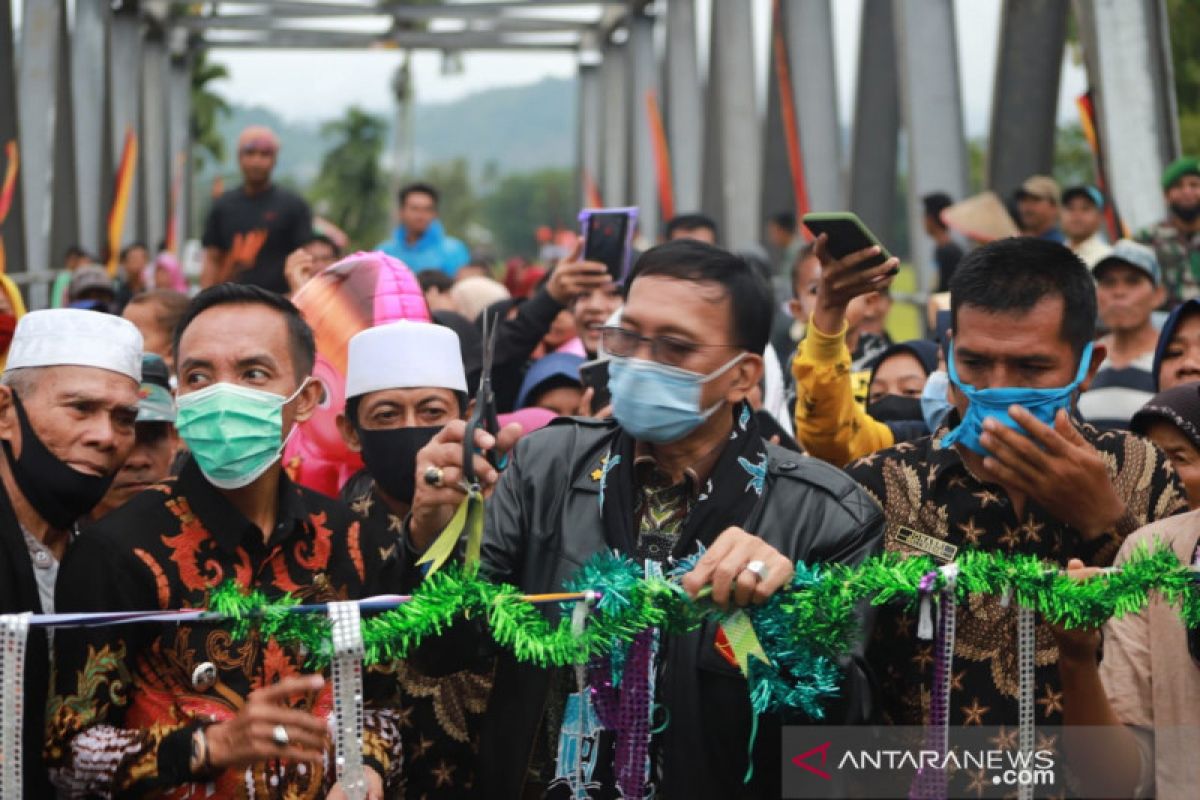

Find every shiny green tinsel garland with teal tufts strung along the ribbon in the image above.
[209,547,1200,717]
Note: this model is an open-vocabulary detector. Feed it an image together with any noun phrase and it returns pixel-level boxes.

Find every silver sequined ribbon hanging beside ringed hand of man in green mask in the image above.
[329,601,367,800]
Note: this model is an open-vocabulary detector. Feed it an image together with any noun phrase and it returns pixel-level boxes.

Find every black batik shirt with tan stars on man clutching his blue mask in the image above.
[846,425,1187,729]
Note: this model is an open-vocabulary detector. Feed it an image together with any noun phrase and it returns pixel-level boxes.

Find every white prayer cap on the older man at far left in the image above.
[5,308,142,384]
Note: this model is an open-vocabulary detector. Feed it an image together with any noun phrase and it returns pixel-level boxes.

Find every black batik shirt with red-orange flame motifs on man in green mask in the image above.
[47,462,401,799]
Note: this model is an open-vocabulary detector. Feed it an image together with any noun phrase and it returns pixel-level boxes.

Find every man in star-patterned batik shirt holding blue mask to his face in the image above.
[847,237,1186,791]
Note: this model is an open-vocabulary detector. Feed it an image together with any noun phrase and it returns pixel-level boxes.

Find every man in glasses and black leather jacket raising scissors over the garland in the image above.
[403,241,881,799]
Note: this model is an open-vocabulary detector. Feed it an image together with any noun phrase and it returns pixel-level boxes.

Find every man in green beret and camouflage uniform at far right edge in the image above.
[1134,156,1200,308]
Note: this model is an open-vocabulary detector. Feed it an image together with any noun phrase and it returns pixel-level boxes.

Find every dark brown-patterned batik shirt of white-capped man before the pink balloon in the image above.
[348,480,492,800]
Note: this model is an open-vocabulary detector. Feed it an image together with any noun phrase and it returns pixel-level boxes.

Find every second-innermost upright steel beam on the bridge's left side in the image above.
[138,28,170,248]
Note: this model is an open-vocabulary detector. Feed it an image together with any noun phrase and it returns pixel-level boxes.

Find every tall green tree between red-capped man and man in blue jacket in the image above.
[311,106,388,247]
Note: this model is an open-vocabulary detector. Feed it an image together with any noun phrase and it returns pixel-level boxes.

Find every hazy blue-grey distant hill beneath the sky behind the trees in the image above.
[200,78,576,186]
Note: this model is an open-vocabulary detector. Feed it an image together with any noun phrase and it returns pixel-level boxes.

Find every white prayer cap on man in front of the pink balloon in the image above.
[346,321,467,398]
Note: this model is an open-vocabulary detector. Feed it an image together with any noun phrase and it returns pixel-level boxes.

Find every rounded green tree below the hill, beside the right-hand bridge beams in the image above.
[481,169,577,258]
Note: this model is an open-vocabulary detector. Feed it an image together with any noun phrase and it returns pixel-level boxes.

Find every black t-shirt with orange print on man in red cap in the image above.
[202,186,312,294]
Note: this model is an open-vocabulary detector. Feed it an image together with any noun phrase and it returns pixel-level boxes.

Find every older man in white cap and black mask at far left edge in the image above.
[0,308,142,798]
